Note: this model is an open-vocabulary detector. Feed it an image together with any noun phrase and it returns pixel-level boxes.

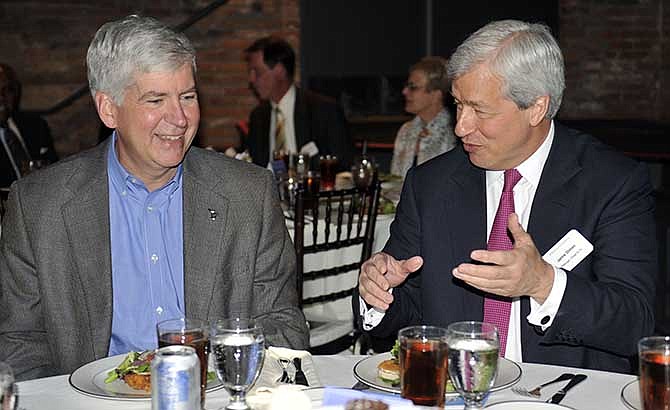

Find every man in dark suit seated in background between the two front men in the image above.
[243,37,353,170]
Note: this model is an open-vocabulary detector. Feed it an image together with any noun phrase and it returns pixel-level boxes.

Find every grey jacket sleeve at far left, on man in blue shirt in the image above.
[0,185,55,380]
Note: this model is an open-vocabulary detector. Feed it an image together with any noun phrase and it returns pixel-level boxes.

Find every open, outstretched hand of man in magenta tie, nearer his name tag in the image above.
[452,213,554,304]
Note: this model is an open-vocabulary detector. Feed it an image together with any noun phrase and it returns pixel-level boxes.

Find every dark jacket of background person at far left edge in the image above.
[0,111,58,187]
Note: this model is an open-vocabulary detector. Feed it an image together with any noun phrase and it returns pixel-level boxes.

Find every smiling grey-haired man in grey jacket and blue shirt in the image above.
[0,15,309,380]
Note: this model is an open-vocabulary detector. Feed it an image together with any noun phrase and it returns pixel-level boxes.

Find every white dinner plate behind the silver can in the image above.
[69,354,223,400]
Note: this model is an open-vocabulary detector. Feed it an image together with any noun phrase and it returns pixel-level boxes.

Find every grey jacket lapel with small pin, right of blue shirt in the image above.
[183,149,228,319]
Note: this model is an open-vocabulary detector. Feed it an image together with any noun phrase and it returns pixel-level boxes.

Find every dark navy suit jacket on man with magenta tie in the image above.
[353,124,658,372]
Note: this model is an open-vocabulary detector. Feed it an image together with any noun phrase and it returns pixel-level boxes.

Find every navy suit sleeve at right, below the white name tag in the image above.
[544,163,658,356]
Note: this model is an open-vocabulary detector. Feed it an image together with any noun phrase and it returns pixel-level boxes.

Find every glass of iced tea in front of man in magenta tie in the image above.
[398,326,448,407]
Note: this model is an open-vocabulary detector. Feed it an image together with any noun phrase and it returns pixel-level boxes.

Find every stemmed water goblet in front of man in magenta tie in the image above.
[447,321,500,410]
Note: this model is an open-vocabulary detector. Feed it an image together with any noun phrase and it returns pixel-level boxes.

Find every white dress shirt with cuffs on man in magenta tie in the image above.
[360,121,567,362]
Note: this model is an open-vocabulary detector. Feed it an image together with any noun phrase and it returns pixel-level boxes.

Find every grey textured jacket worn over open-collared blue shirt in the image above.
[0,143,308,379]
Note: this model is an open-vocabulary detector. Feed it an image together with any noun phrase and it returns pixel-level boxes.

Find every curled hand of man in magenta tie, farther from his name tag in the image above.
[358,252,423,310]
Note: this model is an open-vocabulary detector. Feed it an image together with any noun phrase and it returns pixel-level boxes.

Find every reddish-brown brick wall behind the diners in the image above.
[0,0,670,155]
